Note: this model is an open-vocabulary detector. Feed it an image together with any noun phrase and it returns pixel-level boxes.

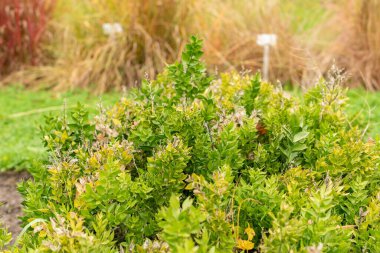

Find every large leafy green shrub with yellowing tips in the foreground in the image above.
[8,38,380,252]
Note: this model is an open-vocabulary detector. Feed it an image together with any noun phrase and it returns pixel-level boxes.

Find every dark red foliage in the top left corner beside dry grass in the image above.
[0,0,54,75]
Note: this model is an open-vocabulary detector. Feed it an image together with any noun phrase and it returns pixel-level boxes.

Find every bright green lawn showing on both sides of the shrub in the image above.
[0,87,380,170]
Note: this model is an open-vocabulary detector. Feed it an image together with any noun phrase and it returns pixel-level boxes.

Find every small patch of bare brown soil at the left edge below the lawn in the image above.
[0,171,30,241]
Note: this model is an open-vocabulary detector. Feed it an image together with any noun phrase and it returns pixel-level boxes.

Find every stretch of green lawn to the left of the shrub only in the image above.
[0,87,120,171]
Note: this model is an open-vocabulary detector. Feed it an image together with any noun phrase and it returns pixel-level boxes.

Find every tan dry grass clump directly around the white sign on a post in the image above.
[193,0,306,82]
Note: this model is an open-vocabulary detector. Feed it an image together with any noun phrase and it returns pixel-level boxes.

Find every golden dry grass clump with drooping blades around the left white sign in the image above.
[4,0,186,93]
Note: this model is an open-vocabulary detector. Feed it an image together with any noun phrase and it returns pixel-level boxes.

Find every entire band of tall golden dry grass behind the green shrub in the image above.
[2,0,380,93]
